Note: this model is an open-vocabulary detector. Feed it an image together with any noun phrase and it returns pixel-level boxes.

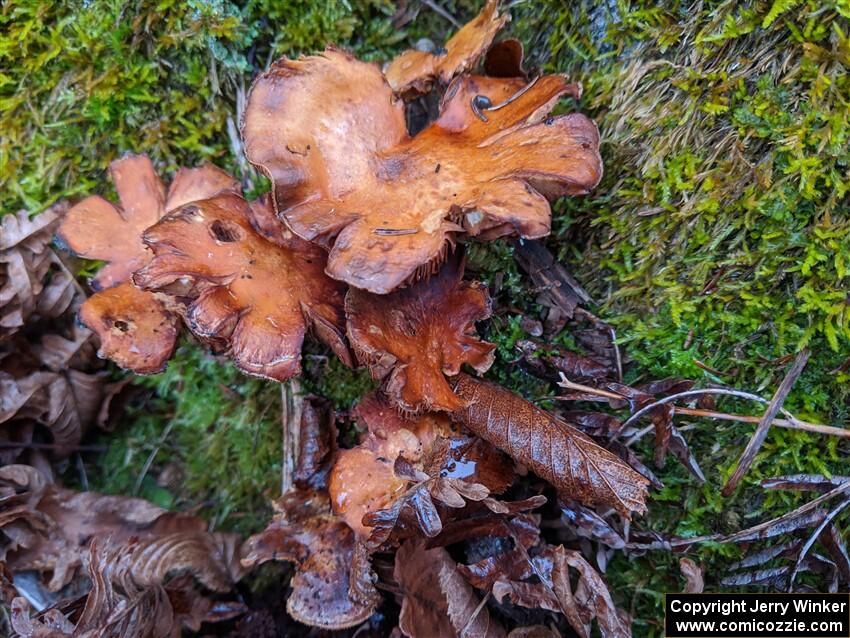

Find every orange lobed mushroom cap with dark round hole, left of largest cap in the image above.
[134,194,351,381]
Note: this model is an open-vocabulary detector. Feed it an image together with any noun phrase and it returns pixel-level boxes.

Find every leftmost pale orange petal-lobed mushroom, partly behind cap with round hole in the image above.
[57,155,240,374]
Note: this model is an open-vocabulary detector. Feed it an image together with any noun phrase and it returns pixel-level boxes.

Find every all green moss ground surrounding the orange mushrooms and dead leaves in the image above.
[0,0,850,635]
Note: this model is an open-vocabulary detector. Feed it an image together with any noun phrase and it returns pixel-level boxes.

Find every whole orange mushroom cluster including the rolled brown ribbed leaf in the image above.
[38,0,647,629]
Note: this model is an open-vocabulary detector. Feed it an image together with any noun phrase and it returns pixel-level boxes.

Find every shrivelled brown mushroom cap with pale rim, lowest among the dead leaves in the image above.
[242,490,379,630]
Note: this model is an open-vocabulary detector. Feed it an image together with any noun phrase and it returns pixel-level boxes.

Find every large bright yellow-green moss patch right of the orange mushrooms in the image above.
[504,2,850,419]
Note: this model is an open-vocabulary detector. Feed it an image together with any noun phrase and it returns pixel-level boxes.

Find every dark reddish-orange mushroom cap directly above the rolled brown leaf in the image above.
[345,258,495,414]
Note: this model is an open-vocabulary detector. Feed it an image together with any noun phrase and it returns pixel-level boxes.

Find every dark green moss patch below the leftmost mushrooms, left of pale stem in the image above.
[77,343,281,532]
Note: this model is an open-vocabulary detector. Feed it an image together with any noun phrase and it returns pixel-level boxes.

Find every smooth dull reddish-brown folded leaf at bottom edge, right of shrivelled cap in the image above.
[393,541,505,638]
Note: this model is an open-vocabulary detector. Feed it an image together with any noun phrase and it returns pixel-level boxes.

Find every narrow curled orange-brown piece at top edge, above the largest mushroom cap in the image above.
[384,0,510,99]
